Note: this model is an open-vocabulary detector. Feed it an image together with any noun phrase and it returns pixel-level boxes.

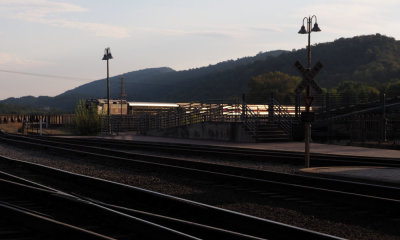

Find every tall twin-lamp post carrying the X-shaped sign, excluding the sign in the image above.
[299,15,321,168]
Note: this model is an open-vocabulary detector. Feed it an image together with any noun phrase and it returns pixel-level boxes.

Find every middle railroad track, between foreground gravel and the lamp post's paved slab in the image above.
[0,135,400,217]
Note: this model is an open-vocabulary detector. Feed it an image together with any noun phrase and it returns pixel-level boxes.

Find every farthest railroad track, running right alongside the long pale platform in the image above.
[37,133,400,167]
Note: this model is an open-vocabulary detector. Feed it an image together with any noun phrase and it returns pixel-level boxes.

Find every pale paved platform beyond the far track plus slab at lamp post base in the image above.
[97,133,400,187]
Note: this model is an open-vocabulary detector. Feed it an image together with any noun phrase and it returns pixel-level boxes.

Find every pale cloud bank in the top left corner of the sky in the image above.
[0,0,129,39]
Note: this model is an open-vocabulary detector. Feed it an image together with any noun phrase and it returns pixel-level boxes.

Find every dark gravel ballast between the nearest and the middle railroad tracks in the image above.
[0,143,400,239]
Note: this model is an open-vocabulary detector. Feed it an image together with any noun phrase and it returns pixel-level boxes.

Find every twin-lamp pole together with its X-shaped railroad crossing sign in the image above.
[295,15,322,168]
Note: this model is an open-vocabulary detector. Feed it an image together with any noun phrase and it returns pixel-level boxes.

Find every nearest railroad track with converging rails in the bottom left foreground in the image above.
[0,157,338,239]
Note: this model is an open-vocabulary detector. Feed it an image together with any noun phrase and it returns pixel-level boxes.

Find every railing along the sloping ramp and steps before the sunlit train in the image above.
[104,101,292,135]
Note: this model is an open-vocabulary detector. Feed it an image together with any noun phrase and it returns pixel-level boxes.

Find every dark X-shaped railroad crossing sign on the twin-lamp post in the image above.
[294,61,323,94]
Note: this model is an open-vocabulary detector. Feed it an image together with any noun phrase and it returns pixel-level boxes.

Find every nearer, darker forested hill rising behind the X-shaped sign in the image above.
[165,34,400,100]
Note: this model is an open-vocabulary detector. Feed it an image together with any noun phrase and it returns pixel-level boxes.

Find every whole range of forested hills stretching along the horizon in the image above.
[3,34,400,110]
